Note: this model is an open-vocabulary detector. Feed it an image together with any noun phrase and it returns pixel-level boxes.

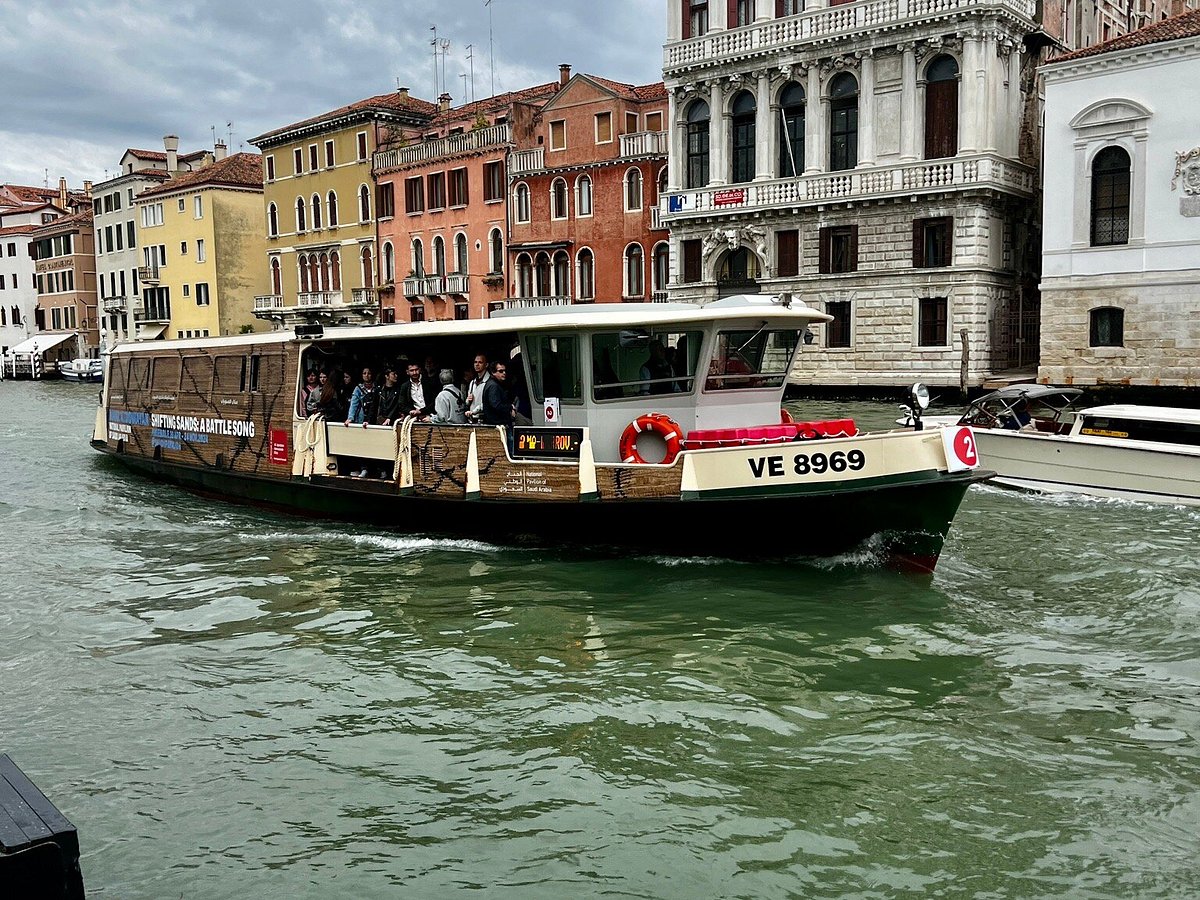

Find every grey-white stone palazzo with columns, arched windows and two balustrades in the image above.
[662,0,1038,385]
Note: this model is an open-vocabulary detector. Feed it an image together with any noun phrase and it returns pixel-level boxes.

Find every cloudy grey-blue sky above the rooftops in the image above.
[0,0,666,188]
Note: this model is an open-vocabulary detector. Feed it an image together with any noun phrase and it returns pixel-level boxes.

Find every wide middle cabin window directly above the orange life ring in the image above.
[592,329,704,400]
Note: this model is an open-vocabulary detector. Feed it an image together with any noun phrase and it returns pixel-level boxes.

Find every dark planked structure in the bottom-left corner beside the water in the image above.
[0,754,84,900]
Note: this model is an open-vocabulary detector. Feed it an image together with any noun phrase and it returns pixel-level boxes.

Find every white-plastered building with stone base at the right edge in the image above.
[1038,11,1200,386]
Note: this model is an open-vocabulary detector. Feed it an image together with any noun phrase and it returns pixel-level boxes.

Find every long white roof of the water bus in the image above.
[113,294,833,353]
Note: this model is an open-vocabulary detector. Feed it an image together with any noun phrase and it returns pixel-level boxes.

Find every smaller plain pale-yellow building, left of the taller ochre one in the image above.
[133,154,268,340]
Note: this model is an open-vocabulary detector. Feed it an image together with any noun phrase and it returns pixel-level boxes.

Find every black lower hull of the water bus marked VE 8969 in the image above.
[94,442,991,574]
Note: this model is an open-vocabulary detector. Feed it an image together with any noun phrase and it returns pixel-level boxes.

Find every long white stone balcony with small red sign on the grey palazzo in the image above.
[660,154,1034,224]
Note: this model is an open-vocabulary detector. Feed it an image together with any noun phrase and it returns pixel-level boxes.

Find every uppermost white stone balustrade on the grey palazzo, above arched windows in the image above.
[662,0,1036,75]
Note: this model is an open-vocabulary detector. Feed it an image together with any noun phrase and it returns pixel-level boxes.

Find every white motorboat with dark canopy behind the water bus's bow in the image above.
[907,384,1200,506]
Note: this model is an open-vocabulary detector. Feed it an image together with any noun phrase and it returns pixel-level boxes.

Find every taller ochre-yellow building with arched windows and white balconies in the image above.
[251,89,437,324]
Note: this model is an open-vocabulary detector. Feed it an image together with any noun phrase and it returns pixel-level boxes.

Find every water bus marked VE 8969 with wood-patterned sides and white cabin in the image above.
[92,295,990,572]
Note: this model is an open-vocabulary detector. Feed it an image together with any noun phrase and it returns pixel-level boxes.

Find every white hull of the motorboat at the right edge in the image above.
[974,428,1200,506]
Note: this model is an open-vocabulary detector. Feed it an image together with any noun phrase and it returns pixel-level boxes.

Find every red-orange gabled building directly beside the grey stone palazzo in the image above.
[508,75,670,306]
